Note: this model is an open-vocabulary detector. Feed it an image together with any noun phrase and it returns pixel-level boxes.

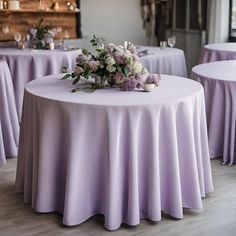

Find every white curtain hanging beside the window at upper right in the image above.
[207,0,229,43]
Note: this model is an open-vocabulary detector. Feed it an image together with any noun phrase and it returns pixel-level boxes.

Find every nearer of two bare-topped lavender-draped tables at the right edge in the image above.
[192,60,236,165]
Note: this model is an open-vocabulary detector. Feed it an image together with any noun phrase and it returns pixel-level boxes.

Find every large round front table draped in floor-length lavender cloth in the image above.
[16,75,213,230]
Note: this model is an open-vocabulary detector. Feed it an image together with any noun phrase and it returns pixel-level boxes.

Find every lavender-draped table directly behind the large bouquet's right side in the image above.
[138,46,187,78]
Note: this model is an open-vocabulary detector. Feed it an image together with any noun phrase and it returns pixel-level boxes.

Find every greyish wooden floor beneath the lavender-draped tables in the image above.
[0,159,236,236]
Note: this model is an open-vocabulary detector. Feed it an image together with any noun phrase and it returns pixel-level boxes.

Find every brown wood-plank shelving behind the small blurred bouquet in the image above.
[0,0,81,41]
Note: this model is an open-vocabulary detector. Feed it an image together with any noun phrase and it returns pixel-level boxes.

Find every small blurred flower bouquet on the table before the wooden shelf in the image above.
[29,19,57,49]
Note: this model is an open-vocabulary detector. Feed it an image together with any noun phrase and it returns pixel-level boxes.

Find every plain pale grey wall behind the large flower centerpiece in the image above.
[80,0,147,48]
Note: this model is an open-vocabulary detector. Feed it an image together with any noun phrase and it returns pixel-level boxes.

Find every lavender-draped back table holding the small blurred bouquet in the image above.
[0,48,81,117]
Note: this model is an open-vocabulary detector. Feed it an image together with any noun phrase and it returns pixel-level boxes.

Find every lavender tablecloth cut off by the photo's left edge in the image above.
[0,61,19,165]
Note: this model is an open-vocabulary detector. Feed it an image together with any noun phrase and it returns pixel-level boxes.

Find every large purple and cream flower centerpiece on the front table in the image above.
[62,35,160,92]
